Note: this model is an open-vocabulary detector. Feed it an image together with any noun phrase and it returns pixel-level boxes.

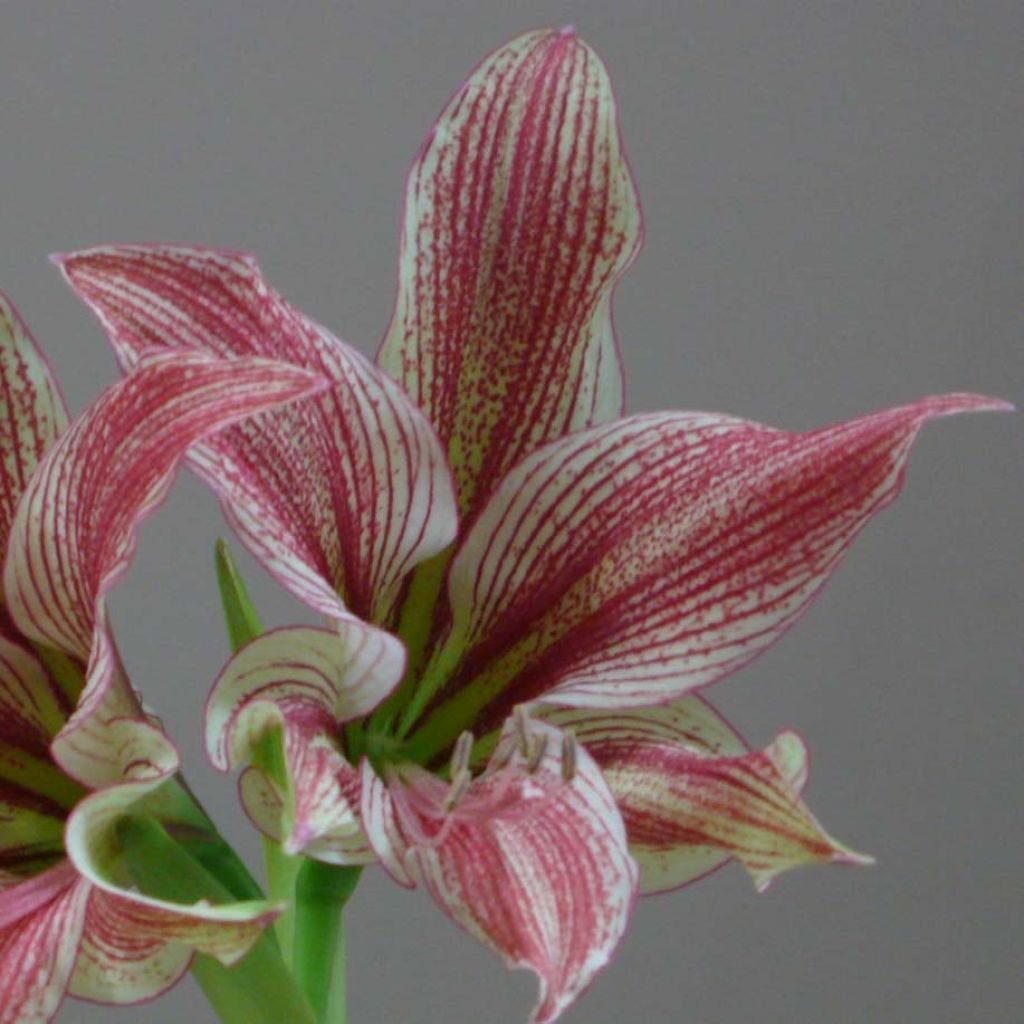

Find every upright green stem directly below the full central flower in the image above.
[292,860,362,1024]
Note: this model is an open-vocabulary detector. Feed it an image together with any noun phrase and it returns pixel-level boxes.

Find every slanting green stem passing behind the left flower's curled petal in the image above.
[117,817,314,1024]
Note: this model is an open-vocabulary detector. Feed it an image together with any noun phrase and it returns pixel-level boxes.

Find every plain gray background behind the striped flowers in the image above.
[0,0,1024,1024]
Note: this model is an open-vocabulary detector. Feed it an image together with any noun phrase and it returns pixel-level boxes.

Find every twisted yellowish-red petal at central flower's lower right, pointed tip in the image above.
[544,697,871,895]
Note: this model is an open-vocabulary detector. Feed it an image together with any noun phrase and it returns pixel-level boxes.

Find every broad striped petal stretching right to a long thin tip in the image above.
[407,394,1007,756]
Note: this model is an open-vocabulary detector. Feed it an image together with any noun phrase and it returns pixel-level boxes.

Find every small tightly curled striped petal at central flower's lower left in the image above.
[206,620,406,863]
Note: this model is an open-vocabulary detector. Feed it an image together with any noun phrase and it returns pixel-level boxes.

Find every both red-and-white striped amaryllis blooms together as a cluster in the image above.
[0,22,1005,1024]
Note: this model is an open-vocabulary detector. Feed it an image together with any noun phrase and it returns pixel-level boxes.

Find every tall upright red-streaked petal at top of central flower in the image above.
[378,30,642,515]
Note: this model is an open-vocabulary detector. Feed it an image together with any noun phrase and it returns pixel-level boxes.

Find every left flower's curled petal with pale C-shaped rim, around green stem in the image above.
[65,764,280,966]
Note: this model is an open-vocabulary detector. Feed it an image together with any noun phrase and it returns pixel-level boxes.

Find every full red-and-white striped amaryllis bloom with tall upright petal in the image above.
[60,24,1001,1022]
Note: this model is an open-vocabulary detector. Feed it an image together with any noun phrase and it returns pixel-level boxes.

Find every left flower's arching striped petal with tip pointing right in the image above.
[4,352,322,785]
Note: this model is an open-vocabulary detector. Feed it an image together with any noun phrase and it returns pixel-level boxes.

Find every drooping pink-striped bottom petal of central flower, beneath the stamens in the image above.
[367,719,637,1024]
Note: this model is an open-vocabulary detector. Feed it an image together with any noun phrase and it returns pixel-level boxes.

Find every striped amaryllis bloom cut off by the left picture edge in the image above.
[0,296,319,1024]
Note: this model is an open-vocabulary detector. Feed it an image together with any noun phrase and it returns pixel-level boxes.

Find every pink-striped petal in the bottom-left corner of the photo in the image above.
[0,862,90,1024]
